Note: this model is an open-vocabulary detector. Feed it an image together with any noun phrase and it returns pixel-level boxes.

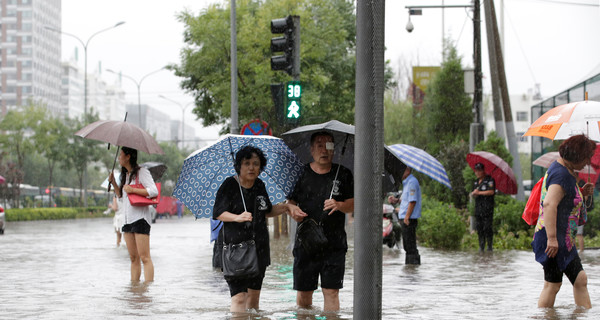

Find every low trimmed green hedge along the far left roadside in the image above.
[6,207,106,221]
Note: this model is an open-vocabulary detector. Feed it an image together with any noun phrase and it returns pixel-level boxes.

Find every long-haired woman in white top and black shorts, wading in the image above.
[108,147,158,281]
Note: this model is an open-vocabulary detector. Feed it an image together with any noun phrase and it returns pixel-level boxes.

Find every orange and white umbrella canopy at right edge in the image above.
[523,101,600,141]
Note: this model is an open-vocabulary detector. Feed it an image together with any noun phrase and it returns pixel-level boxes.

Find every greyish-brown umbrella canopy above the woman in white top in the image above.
[75,120,164,154]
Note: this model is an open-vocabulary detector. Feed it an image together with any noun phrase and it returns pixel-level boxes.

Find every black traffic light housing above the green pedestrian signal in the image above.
[271,16,300,77]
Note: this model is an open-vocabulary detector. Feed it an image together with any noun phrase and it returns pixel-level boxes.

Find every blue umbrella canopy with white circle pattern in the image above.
[173,135,303,218]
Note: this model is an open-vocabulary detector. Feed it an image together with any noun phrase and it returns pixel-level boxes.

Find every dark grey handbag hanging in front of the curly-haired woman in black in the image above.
[222,226,260,279]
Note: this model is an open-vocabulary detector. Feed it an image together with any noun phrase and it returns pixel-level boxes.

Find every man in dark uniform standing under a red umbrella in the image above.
[471,163,496,251]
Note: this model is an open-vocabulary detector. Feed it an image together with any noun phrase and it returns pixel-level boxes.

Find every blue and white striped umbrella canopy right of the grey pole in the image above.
[388,144,452,189]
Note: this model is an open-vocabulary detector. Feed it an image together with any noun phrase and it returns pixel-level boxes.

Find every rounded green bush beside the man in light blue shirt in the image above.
[417,198,466,249]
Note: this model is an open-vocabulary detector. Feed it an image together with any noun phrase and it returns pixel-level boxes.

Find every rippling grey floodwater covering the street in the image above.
[0,217,600,320]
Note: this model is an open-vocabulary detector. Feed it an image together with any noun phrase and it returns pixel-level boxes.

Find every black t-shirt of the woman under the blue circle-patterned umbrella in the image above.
[213,177,273,267]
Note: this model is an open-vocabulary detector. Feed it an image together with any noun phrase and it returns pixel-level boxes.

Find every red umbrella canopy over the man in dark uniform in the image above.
[467,151,517,194]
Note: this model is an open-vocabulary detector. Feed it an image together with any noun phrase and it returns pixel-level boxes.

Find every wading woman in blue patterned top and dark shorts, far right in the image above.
[531,135,596,308]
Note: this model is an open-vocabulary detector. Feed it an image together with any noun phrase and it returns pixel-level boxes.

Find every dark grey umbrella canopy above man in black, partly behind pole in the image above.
[281,120,406,192]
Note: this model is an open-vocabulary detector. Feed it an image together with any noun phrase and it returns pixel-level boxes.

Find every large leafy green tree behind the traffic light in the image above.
[169,0,393,134]
